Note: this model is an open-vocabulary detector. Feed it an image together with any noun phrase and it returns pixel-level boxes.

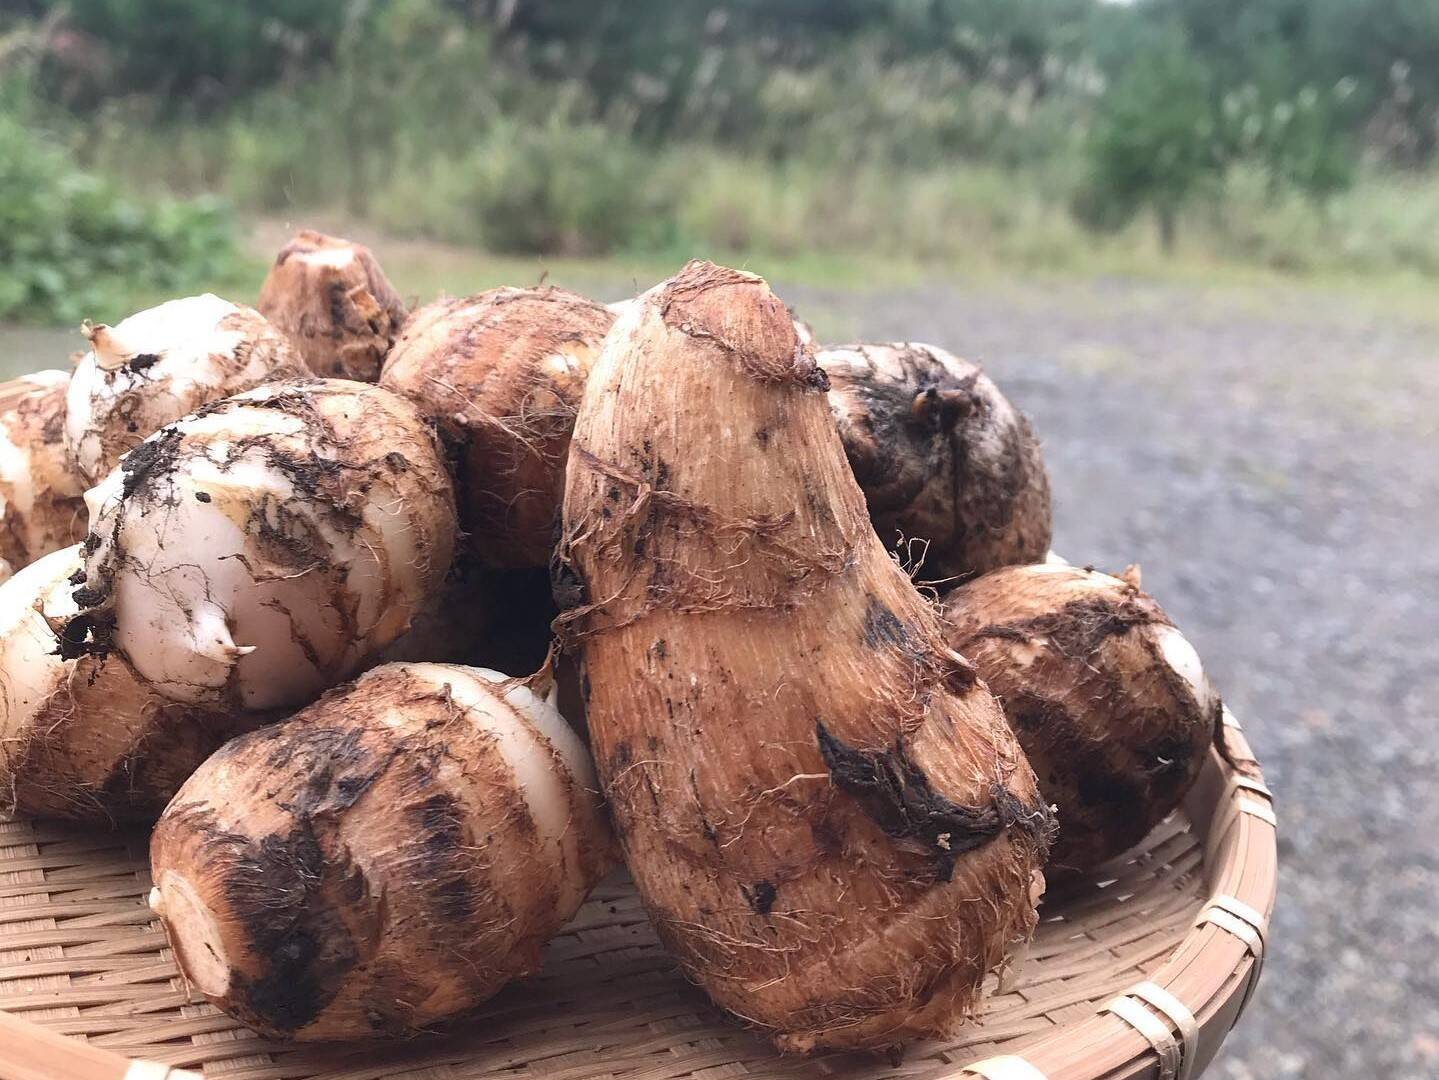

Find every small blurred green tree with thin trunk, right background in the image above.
[1075,37,1223,252]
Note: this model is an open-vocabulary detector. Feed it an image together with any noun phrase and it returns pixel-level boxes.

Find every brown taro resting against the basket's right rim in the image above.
[944,564,1222,873]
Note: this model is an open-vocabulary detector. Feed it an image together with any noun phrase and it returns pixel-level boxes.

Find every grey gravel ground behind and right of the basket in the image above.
[0,274,1439,1080]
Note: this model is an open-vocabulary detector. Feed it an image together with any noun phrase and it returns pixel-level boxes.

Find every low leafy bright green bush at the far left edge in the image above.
[0,109,233,322]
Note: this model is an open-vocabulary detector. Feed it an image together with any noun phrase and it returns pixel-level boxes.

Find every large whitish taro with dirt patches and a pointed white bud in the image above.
[60,380,455,709]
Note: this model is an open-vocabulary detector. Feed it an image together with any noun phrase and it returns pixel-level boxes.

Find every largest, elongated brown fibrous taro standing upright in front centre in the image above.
[554,262,1052,1050]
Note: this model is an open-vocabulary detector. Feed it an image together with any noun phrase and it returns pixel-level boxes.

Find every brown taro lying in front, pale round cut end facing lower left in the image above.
[150,664,613,1040]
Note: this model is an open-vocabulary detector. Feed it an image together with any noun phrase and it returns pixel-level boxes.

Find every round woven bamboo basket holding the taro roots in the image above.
[0,383,1276,1080]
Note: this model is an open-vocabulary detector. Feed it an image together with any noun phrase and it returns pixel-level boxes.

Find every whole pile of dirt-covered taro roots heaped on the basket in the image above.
[0,232,1222,1053]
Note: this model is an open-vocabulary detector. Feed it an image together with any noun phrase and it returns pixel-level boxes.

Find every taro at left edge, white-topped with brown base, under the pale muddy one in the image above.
[0,545,256,820]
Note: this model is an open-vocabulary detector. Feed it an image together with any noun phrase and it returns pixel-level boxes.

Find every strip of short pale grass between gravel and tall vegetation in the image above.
[19,214,1439,342]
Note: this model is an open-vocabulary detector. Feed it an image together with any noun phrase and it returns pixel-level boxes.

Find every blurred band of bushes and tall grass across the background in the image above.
[0,0,1439,319]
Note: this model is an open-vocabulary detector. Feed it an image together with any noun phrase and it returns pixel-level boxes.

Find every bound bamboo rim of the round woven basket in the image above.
[0,708,1278,1080]
